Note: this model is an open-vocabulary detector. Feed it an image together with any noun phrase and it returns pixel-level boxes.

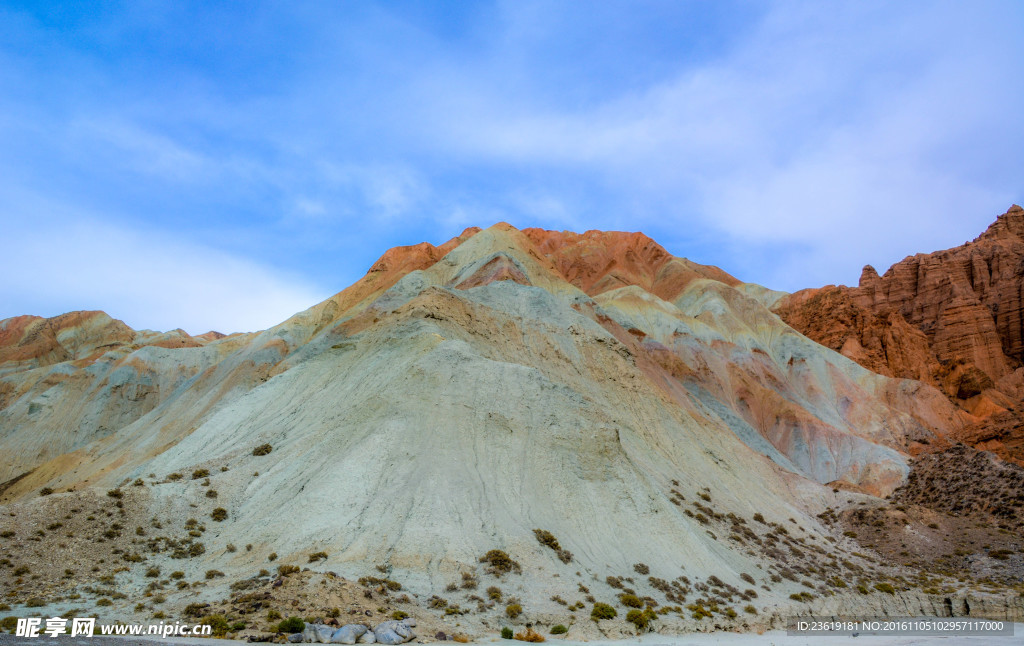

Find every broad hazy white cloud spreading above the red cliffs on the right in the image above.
[385,3,1024,289]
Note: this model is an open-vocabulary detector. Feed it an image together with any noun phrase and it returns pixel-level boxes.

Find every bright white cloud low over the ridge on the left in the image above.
[0,194,330,334]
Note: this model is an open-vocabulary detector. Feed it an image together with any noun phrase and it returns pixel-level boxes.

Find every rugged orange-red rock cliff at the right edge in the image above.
[775,205,1024,464]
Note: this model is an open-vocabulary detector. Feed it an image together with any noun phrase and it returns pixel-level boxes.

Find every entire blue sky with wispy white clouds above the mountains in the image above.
[0,0,1024,334]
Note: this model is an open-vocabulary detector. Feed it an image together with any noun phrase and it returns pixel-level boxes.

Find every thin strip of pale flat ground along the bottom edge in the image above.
[0,623,1024,646]
